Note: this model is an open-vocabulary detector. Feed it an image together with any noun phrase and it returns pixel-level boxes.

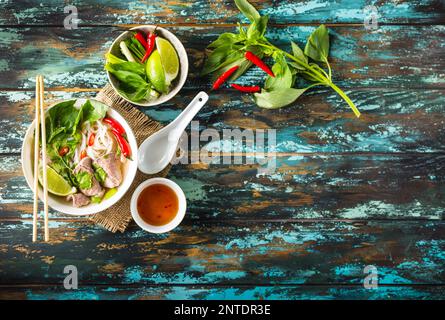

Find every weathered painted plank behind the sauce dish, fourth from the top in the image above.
[0,154,445,221]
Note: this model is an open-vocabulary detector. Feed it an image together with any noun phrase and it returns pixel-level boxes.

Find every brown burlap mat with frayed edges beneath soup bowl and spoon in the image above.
[89,84,170,232]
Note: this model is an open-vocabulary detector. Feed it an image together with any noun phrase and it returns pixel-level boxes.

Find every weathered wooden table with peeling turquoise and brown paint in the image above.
[0,0,445,299]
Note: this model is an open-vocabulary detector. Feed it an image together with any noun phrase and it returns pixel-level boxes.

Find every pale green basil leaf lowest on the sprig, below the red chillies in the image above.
[254,88,306,109]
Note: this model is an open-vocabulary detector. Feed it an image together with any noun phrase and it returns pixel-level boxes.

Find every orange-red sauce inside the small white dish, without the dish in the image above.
[137,183,179,226]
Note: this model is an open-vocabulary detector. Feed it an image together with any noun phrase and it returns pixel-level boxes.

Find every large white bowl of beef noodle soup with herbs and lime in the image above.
[22,99,137,215]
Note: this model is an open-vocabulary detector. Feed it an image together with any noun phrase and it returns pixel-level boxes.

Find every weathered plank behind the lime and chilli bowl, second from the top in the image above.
[0,25,445,90]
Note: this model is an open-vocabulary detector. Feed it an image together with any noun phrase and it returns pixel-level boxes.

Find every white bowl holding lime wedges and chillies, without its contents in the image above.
[107,25,189,107]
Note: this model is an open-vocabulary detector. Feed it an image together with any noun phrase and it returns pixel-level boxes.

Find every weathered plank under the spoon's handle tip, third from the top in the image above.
[0,89,445,154]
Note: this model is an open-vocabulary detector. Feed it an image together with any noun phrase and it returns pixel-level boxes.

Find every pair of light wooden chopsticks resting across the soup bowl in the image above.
[32,76,49,242]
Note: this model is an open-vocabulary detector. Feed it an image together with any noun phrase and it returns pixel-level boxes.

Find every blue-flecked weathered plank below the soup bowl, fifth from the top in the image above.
[0,220,445,287]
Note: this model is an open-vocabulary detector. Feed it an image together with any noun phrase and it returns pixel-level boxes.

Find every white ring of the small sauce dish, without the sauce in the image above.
[130,178,187,233]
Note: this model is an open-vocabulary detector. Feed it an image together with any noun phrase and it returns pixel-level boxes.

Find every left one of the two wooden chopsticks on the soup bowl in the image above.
[32,76,40,242]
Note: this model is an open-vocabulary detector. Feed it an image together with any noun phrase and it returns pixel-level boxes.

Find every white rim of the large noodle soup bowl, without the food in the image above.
[22,99,138,216]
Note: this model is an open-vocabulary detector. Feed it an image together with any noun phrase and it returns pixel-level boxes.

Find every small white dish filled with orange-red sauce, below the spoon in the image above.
[130,178,187,233]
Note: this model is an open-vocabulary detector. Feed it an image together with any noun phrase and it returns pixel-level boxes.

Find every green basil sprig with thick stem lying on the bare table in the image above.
[201,0,360,117]
